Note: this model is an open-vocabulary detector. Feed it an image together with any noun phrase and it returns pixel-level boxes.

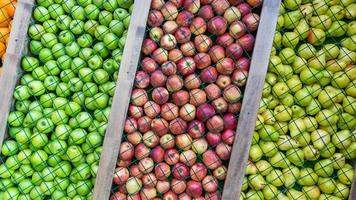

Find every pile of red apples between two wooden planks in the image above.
[111,0,262,200]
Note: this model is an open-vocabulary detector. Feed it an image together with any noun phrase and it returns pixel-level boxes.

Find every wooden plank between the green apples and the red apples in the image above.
[93,0,151,200]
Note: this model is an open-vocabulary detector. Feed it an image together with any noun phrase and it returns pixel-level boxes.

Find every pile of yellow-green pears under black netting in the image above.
[241,0,356,200]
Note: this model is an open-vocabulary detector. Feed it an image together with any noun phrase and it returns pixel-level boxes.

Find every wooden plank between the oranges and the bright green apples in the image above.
[0,0,34,146]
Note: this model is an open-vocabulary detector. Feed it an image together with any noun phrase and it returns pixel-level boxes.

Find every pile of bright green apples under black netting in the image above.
[0,0,133,200]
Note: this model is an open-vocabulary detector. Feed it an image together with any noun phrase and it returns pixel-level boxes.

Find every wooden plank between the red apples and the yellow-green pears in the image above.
[222,0,281,200]
